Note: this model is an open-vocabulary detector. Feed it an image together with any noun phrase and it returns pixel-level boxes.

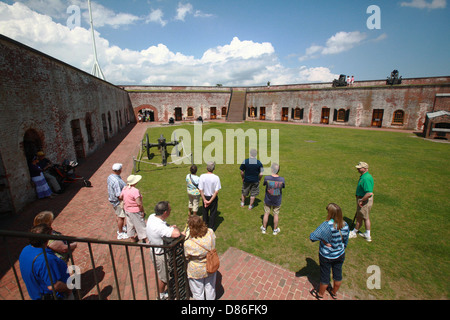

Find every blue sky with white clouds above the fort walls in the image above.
[0,0,450,86]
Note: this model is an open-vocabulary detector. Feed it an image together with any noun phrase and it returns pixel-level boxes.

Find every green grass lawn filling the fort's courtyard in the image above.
[138,122,450,299]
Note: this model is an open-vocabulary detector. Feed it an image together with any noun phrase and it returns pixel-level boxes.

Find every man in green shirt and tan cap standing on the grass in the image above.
[349,162,374,242]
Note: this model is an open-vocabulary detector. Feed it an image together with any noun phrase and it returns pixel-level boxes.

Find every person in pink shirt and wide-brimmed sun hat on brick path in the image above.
[119,175,147,243]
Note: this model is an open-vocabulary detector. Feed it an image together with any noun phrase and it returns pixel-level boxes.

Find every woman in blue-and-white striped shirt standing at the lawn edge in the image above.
[309,203,349,300]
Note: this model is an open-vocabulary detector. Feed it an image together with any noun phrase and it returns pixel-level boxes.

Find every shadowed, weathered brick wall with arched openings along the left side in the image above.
[0,36,134,211]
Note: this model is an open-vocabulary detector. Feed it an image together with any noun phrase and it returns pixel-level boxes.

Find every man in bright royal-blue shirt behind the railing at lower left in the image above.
[19,224,73,300]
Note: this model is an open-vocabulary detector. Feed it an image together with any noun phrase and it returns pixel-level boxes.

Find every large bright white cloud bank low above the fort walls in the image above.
[0,2,335,86]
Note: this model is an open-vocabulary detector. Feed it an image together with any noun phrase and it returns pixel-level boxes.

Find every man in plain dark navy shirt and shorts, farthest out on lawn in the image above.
[239,149,264,210]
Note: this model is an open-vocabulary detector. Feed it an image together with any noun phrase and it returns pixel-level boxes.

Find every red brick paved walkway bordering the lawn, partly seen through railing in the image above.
[0,124,351,300]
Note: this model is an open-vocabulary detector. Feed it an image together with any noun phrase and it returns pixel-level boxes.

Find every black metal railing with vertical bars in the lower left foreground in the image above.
[0,230,189,300]
